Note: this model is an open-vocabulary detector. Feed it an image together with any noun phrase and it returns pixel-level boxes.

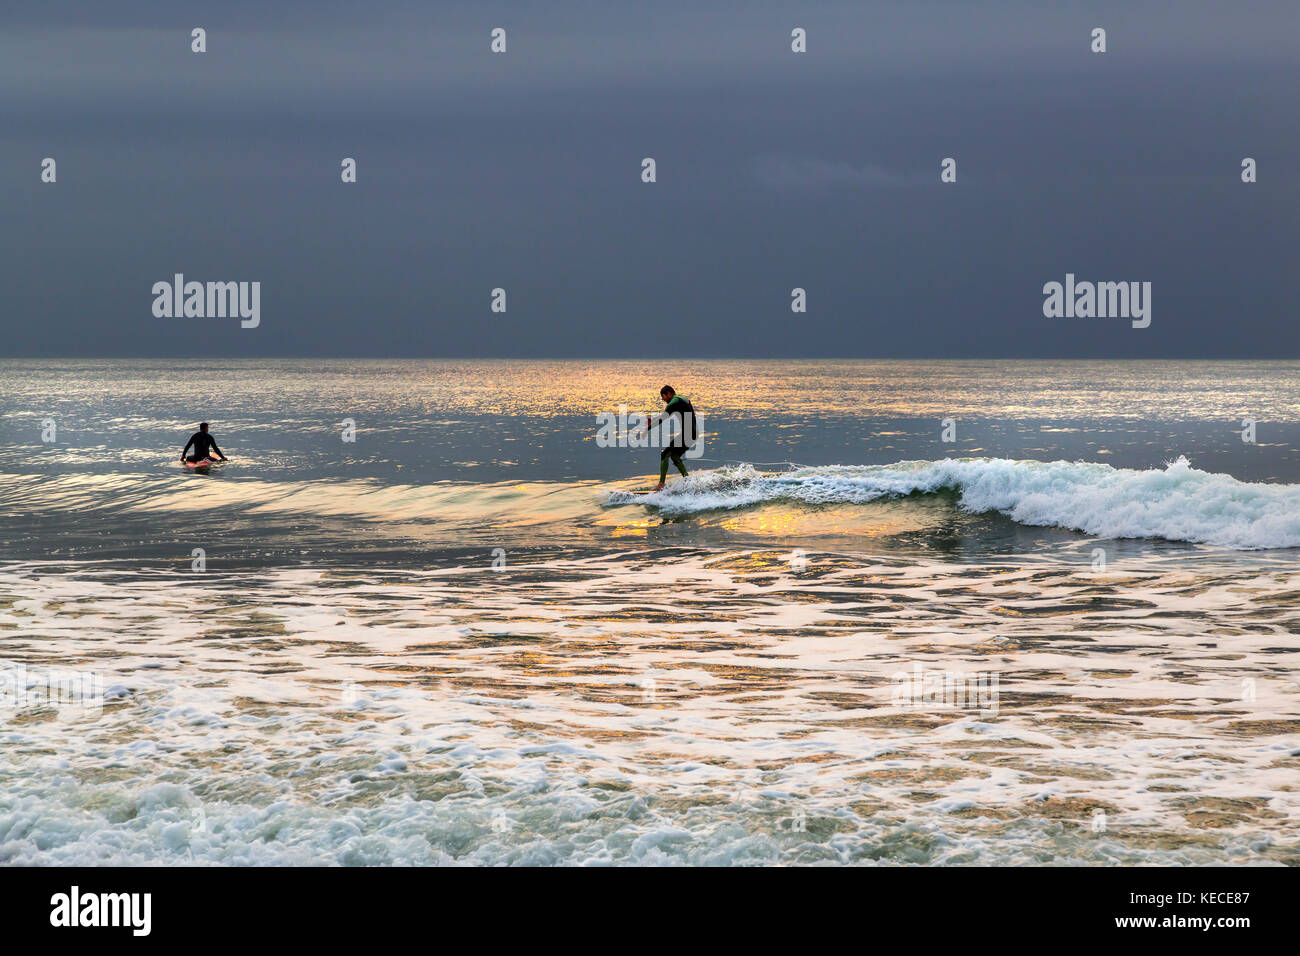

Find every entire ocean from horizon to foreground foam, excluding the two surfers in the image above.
[0,360,1300,865]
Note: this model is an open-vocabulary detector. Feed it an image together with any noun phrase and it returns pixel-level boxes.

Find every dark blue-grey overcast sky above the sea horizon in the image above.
[0,0,1300,358]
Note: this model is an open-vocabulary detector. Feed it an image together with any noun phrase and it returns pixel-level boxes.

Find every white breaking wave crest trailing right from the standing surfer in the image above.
[606,458,1300,550]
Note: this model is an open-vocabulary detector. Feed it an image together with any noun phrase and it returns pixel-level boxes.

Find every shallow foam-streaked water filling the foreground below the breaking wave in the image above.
[0,549,1300,864]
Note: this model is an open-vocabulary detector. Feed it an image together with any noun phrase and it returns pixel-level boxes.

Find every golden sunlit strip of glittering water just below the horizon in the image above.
[0,359,1300,421]
